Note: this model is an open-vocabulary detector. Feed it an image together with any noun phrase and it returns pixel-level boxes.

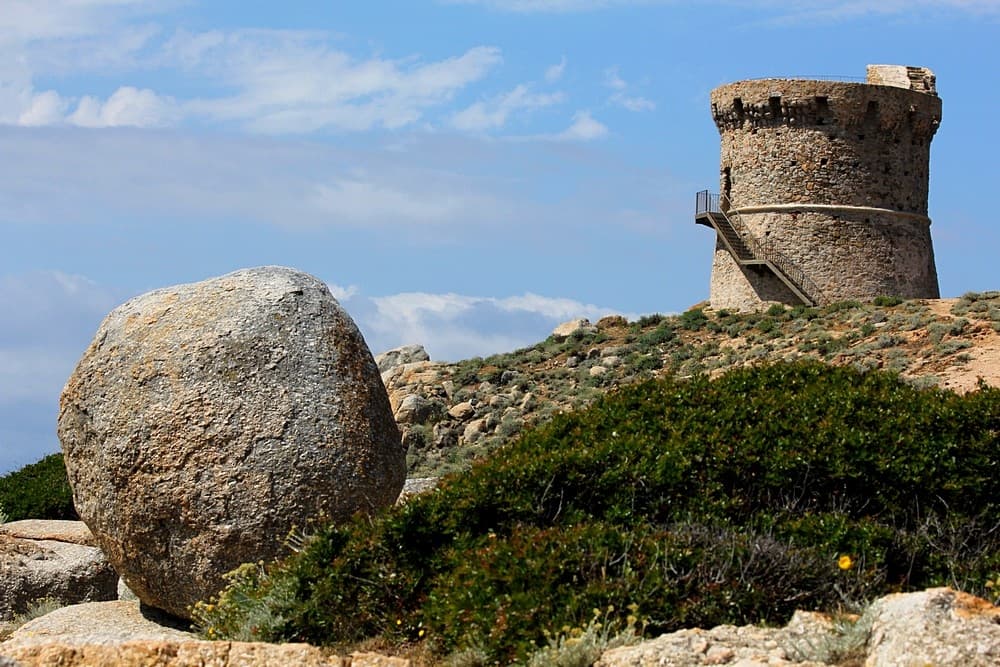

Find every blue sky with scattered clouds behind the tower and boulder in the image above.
[0,0,1000,471]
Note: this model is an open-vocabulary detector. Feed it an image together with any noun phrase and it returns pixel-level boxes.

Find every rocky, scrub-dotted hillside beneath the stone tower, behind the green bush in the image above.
[383,292,1000,477]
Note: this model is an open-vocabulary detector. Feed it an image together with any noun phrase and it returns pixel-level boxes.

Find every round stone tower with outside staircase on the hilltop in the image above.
[696,65,941,310]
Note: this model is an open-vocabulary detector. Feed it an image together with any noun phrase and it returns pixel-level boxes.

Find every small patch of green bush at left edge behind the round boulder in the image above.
[0,454,77,521]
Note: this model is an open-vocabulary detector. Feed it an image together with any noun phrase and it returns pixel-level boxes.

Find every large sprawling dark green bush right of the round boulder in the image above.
[195,363,1000,664]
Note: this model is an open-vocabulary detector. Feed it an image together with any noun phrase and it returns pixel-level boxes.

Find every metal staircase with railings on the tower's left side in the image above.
[694,190,822,306]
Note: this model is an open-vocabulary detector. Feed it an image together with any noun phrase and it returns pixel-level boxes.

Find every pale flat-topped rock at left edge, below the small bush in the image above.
[0,520,118,621]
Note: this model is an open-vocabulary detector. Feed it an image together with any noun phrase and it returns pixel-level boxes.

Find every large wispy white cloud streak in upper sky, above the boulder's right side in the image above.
[176,30,501,133]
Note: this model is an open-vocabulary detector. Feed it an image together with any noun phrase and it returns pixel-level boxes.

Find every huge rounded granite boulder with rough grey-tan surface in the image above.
[58,267,405,617]
